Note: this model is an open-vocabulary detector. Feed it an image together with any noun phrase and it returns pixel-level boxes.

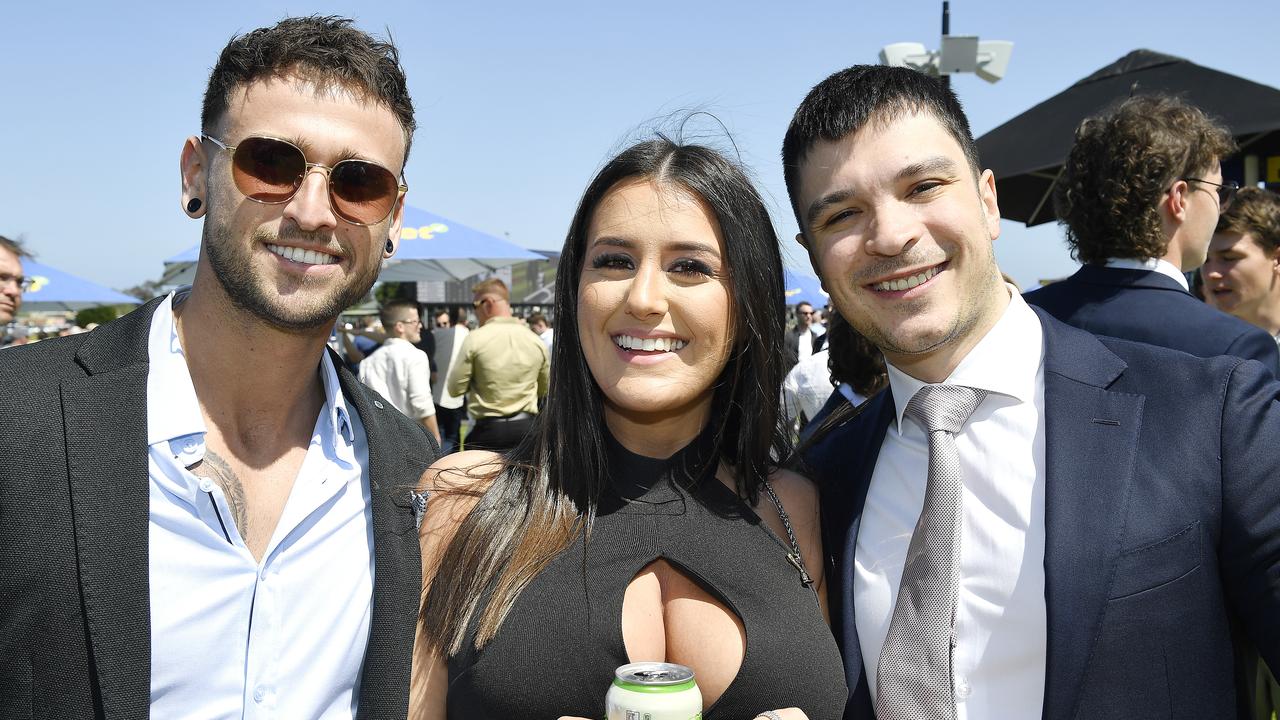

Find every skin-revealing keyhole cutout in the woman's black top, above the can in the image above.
[622,557,746,710]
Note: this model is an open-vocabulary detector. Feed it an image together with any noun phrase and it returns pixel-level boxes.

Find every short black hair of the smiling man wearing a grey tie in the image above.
[782,65,982,233]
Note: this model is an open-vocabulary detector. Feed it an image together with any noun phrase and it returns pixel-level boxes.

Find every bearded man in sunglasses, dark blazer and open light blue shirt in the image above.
[0,17,436,720]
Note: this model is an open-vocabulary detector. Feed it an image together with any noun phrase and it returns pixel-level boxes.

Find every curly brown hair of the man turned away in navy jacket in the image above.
[1053,95,1235,264]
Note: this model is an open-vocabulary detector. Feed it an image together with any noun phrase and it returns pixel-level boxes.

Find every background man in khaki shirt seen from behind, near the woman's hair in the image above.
[448,278,550,452]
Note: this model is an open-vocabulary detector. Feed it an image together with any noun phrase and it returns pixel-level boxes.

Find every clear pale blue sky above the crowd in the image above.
[0,0,1280,288]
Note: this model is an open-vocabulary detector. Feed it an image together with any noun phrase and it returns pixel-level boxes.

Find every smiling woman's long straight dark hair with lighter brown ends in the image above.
[421,137,792,655]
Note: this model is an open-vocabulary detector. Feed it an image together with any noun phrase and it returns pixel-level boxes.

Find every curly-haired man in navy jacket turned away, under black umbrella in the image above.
[1027,95,1280,375]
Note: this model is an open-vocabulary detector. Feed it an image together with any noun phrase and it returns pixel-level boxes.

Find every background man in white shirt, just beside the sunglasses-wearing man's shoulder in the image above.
[360,300,440,445]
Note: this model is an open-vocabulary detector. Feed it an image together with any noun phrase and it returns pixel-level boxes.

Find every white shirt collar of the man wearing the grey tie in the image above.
[886,284,1044,434]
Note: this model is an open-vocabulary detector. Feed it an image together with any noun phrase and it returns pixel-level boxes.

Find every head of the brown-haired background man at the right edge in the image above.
[1201,187,1280,343]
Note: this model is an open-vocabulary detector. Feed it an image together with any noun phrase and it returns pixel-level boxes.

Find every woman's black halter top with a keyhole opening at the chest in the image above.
[448,430,847,720]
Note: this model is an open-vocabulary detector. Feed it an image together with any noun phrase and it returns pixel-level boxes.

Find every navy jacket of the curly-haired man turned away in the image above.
[1023,265,1280,378]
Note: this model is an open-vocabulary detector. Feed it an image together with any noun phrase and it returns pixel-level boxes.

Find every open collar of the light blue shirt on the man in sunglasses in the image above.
[147,292,356,445]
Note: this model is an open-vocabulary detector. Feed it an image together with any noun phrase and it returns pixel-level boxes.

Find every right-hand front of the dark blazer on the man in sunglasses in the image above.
[334,360,435,719]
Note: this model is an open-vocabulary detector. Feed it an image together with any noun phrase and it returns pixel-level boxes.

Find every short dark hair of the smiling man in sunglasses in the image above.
[200,15,417,161]
